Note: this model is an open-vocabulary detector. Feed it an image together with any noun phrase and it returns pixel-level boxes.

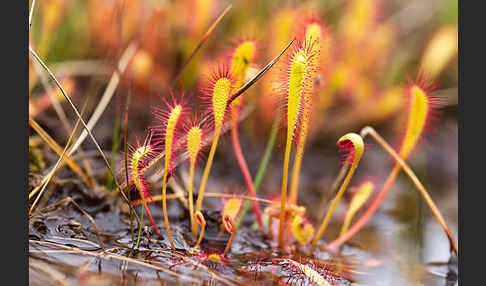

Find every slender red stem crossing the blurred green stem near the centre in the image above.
[231,110,263,229]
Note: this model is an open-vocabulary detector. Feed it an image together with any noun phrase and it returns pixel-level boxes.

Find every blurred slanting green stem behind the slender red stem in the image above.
[236,113,281,229]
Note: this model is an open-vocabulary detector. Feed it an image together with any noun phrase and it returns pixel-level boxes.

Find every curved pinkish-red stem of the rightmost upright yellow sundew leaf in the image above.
[327,164,401,248]
